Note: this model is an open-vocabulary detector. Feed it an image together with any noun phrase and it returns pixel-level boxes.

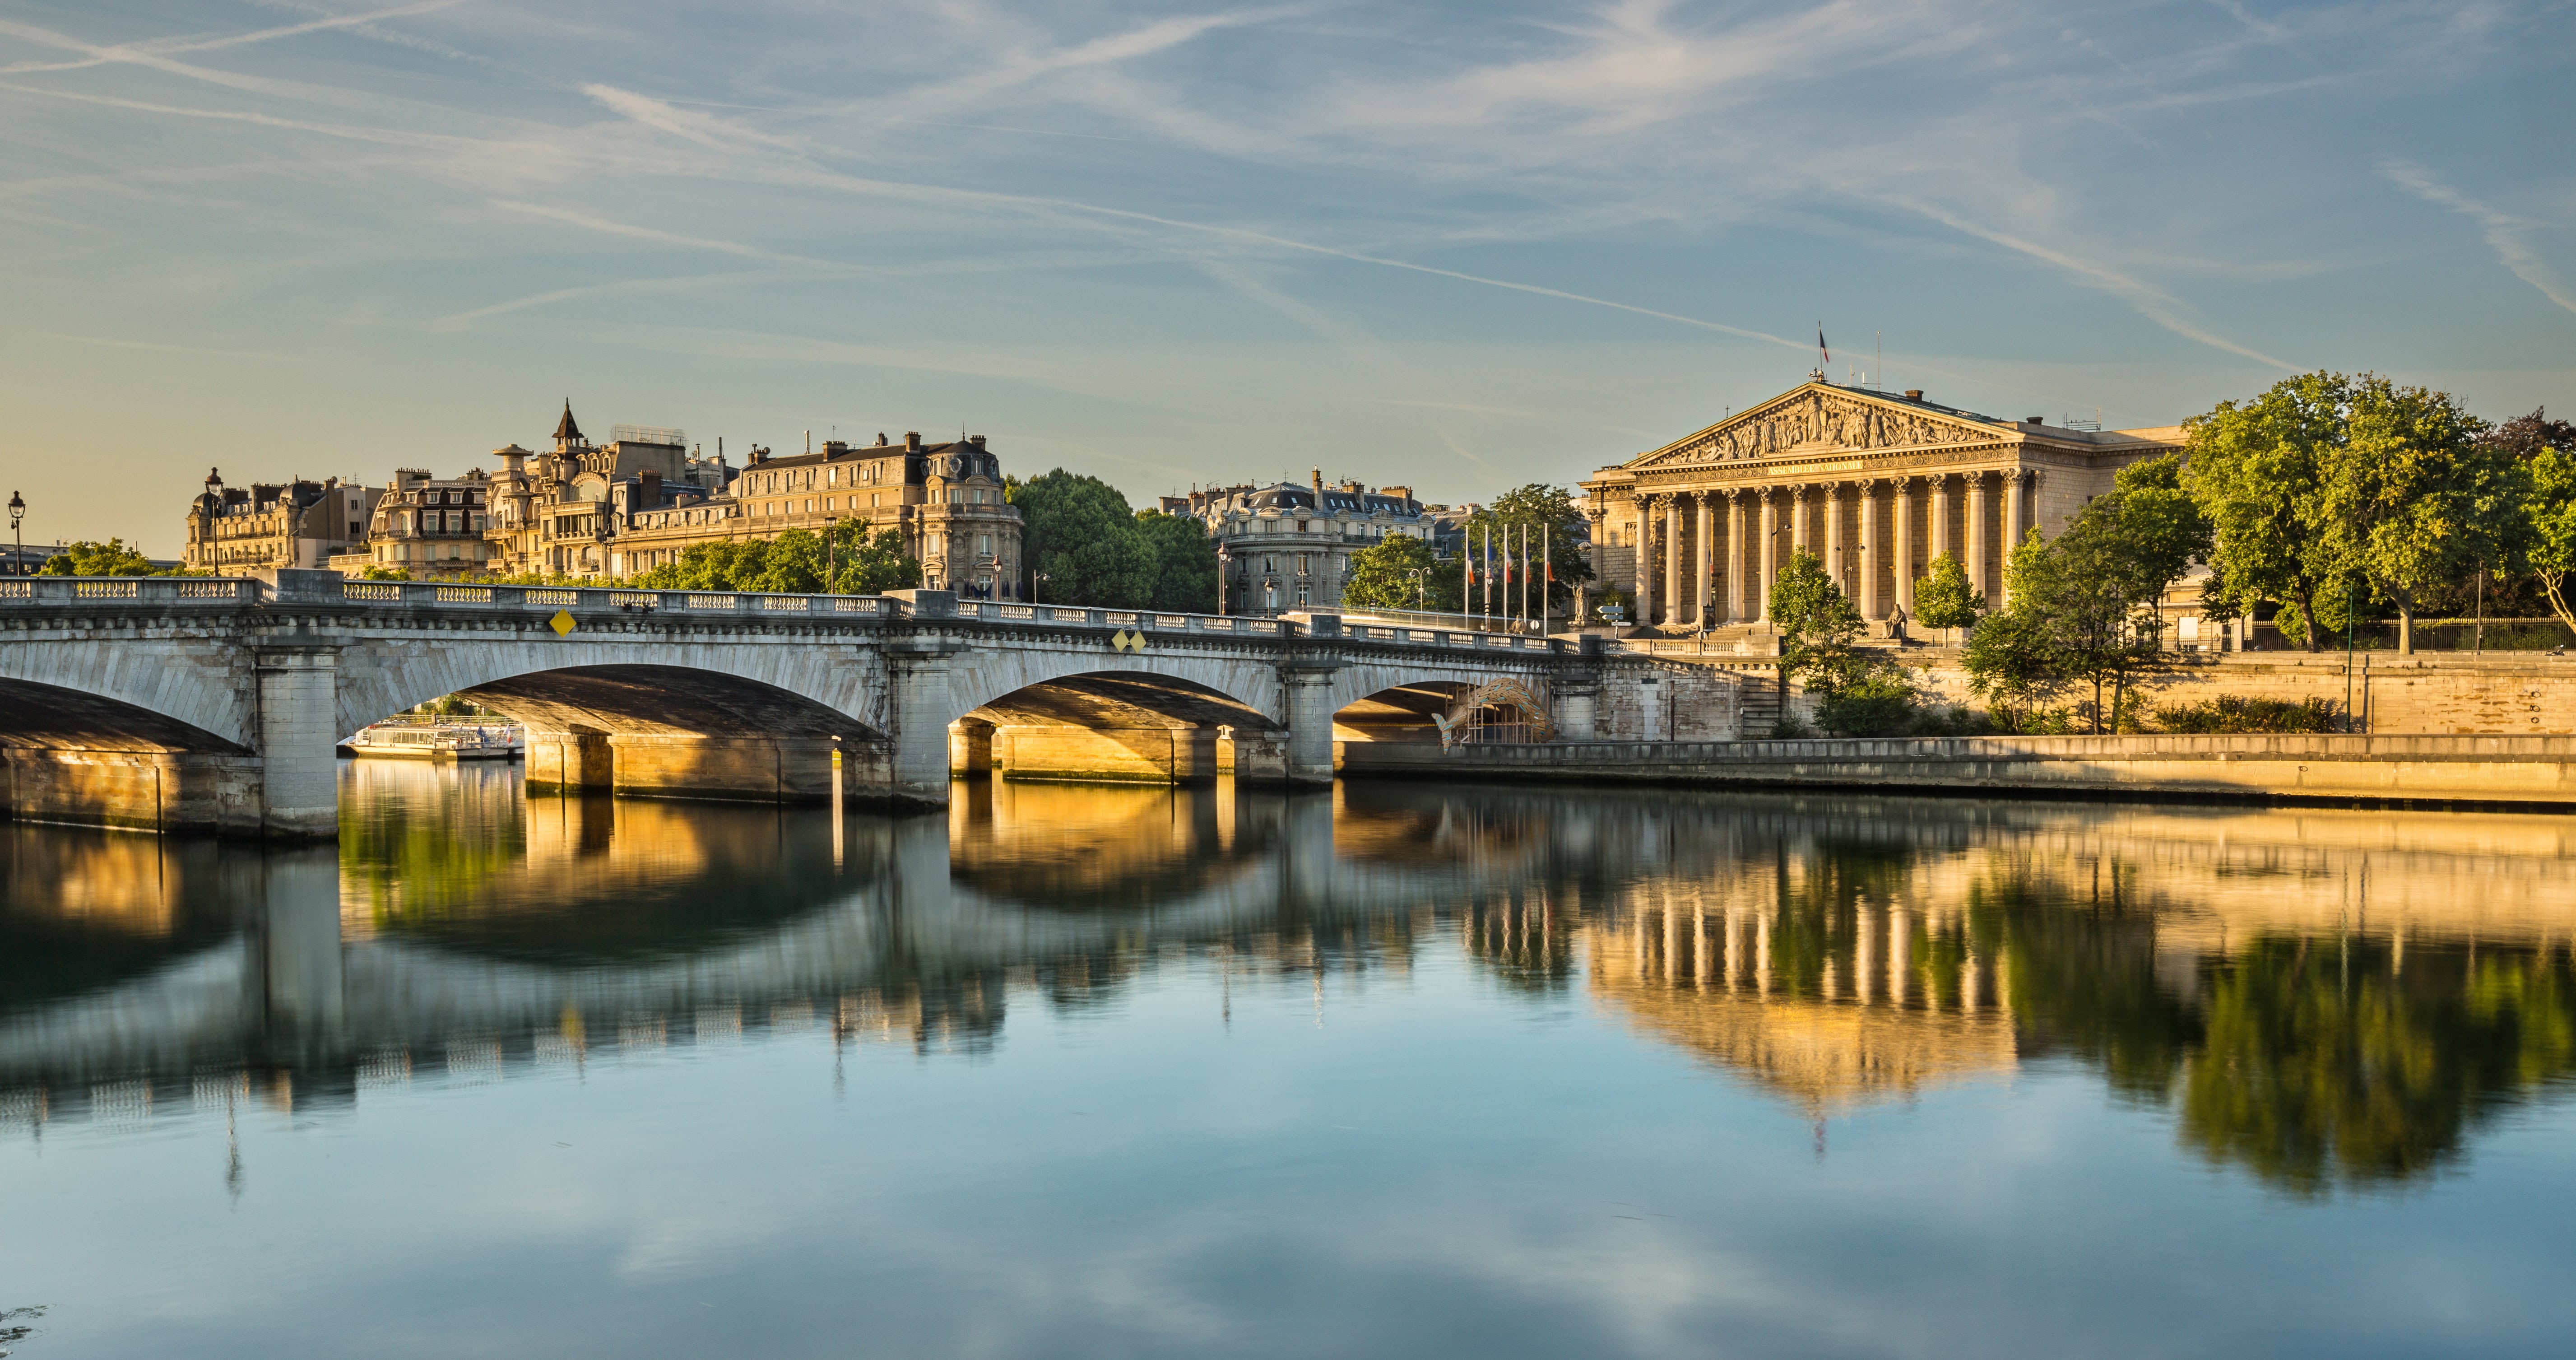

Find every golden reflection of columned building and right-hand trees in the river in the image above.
[1504,798,2576,1195]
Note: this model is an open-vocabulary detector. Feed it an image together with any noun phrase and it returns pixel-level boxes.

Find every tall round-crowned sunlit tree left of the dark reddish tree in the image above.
[2318,373,2522,652]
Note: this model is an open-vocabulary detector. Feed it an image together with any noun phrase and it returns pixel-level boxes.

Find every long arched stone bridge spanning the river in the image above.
[0,572,1739,837]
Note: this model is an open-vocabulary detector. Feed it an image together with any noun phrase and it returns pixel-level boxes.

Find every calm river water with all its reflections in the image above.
[0,763,2576,1360]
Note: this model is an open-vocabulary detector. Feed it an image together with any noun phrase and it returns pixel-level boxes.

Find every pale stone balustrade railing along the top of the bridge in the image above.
[0,572,1564,652]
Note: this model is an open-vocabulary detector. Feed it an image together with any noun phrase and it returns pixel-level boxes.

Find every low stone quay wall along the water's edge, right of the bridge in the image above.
[1334,737,2576,811]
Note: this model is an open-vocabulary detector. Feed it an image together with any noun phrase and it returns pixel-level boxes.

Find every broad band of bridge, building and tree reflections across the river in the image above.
[0,763,2576,1192]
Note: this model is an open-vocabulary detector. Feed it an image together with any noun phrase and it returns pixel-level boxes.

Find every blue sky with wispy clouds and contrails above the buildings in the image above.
[0,0,2576,554]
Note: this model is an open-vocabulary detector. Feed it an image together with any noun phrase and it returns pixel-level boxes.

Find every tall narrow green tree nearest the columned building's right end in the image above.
[2182,371,2352,652]
